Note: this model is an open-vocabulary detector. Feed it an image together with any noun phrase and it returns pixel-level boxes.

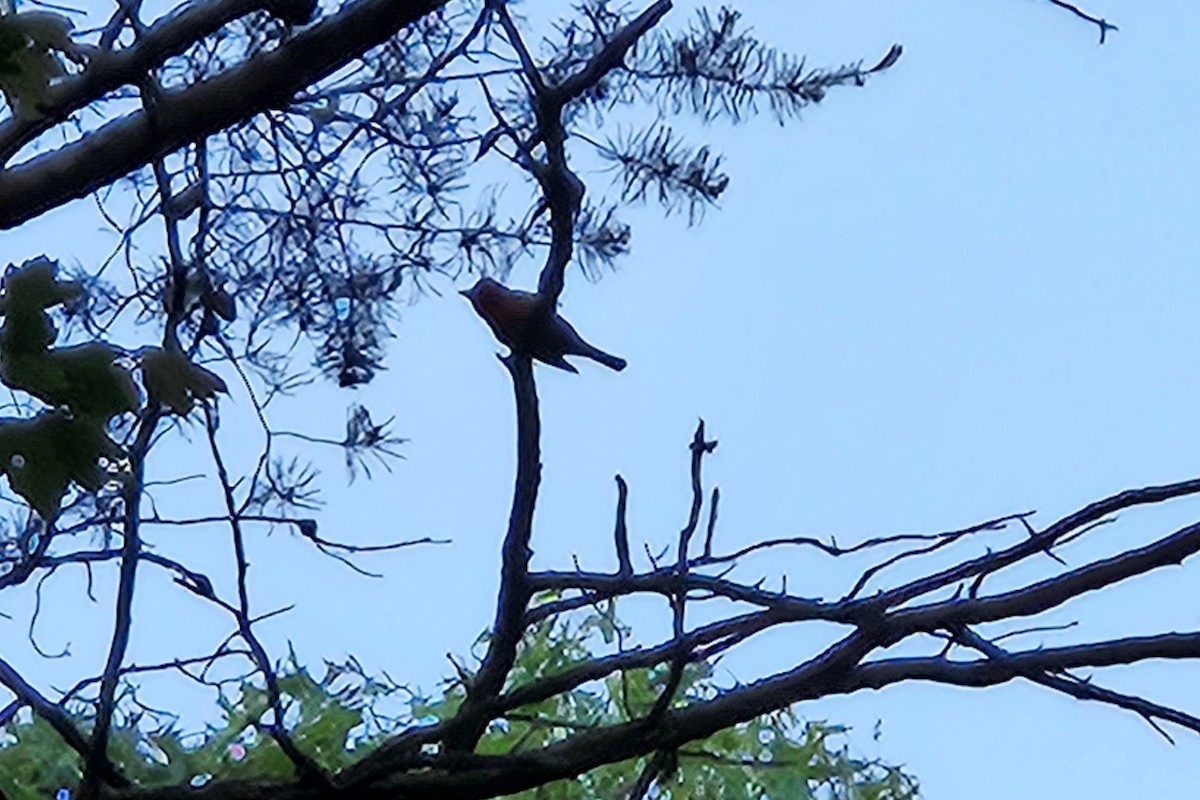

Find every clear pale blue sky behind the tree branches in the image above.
[0,0,1200,800]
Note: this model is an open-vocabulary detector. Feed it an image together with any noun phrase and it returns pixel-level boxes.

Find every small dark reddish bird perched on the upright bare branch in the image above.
[458,278,625,373]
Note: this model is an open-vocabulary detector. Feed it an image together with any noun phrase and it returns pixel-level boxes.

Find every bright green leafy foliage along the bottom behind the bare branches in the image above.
[0,603,917,800]
